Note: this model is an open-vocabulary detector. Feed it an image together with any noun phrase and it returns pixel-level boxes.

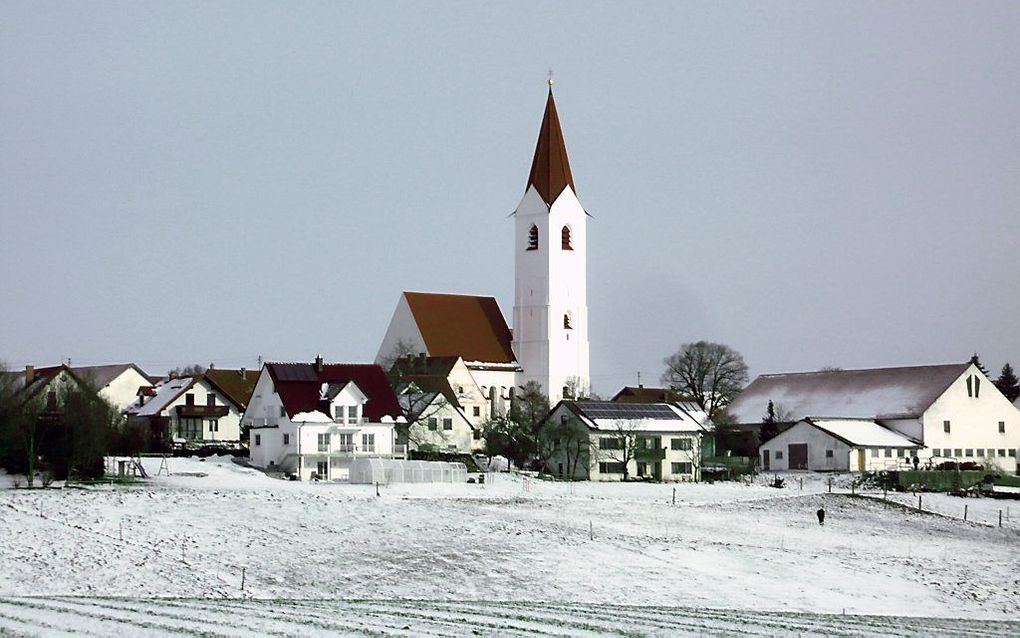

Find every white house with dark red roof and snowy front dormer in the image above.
[244,357,405,481]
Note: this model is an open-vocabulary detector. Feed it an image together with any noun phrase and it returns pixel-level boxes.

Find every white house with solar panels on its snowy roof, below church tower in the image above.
[540,400,713,481]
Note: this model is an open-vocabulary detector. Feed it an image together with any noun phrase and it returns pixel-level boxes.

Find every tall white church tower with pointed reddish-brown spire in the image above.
[513,85,591,403]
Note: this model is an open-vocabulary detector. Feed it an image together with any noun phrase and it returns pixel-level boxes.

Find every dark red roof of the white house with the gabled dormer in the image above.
[265,363,402,423]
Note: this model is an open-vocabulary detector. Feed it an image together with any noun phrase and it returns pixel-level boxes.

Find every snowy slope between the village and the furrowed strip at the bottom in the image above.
[0,458,1020,633]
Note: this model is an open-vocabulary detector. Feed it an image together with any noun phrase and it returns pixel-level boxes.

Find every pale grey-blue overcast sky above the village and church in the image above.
[0,0,1020,394]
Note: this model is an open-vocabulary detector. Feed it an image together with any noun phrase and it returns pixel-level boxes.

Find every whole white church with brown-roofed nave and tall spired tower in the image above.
[375,81,591,413]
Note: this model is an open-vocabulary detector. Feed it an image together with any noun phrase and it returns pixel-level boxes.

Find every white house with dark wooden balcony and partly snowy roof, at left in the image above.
[124,376,242,446]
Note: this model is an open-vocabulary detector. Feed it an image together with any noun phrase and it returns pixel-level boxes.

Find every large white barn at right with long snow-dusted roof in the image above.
[727,362,1020,472]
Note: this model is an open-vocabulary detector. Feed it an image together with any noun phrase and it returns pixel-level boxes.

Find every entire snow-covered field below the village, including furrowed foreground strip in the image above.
[0,458,1020,636]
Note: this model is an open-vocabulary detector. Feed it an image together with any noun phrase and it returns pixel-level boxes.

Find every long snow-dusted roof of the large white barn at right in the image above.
[726,363,970,424]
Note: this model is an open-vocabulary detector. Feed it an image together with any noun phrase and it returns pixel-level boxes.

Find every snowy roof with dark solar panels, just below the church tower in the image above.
[553,400,706,432]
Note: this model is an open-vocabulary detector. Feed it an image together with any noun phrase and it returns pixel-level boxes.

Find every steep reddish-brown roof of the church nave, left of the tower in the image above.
[404,292,516,363]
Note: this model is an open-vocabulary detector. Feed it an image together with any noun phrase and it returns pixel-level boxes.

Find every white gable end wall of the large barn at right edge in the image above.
[921,365,1020,472]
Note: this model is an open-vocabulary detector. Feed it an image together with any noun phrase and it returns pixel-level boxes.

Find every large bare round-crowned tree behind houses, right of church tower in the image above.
[662,341,748,420]
